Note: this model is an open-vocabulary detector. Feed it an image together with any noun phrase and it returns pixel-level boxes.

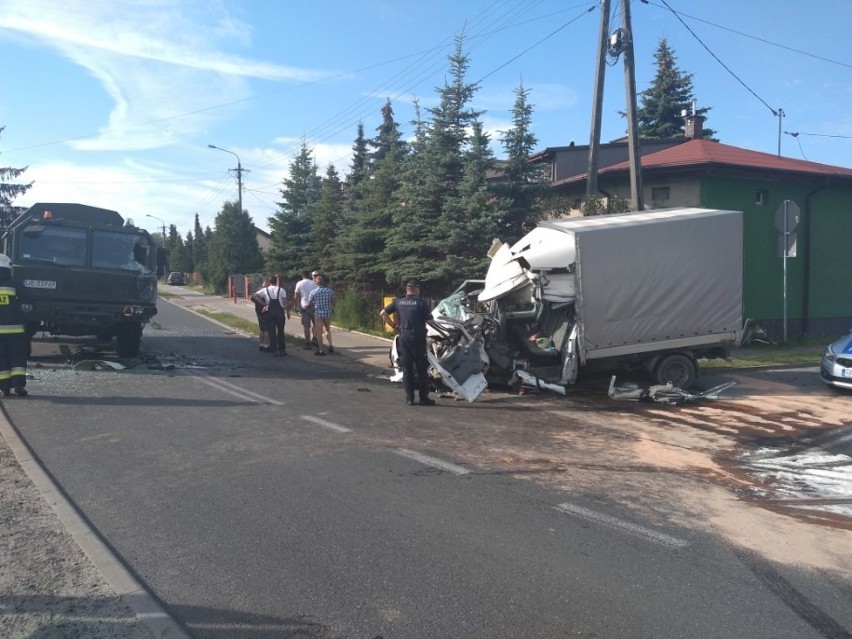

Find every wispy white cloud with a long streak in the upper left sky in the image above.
[0,0,340,150]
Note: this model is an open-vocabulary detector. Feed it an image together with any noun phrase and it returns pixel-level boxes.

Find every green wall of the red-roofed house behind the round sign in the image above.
[699,176,852,334]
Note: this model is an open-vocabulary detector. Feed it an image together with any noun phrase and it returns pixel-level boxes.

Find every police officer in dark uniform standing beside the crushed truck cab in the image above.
[379,279,435,406]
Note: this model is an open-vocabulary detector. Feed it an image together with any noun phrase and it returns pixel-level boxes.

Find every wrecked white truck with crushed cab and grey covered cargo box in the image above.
[422,209,743,401]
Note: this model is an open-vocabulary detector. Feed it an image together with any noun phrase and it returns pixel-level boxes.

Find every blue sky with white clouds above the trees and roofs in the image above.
[0,0,852,235]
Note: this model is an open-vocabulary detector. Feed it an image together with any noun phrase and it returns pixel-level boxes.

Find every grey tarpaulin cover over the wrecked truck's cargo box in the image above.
[548,209,743,357]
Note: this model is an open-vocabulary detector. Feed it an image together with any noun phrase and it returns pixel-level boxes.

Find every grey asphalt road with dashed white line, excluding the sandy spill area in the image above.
[7,304,852,639]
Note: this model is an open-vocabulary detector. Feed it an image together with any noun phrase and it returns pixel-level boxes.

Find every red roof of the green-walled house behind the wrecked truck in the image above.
[554,140,852,184]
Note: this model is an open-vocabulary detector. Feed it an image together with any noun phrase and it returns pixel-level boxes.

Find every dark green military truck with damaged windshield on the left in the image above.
[3,203,165,357]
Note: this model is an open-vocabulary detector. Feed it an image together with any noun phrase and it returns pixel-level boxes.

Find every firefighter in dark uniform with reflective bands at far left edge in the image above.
[0,255,28,397]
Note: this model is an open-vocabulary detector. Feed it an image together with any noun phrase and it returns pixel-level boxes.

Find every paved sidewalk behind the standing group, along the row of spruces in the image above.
[165,284,393,375]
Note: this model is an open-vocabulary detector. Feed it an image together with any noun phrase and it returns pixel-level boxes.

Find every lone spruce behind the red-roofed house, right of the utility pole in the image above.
[636,38,715,140]
